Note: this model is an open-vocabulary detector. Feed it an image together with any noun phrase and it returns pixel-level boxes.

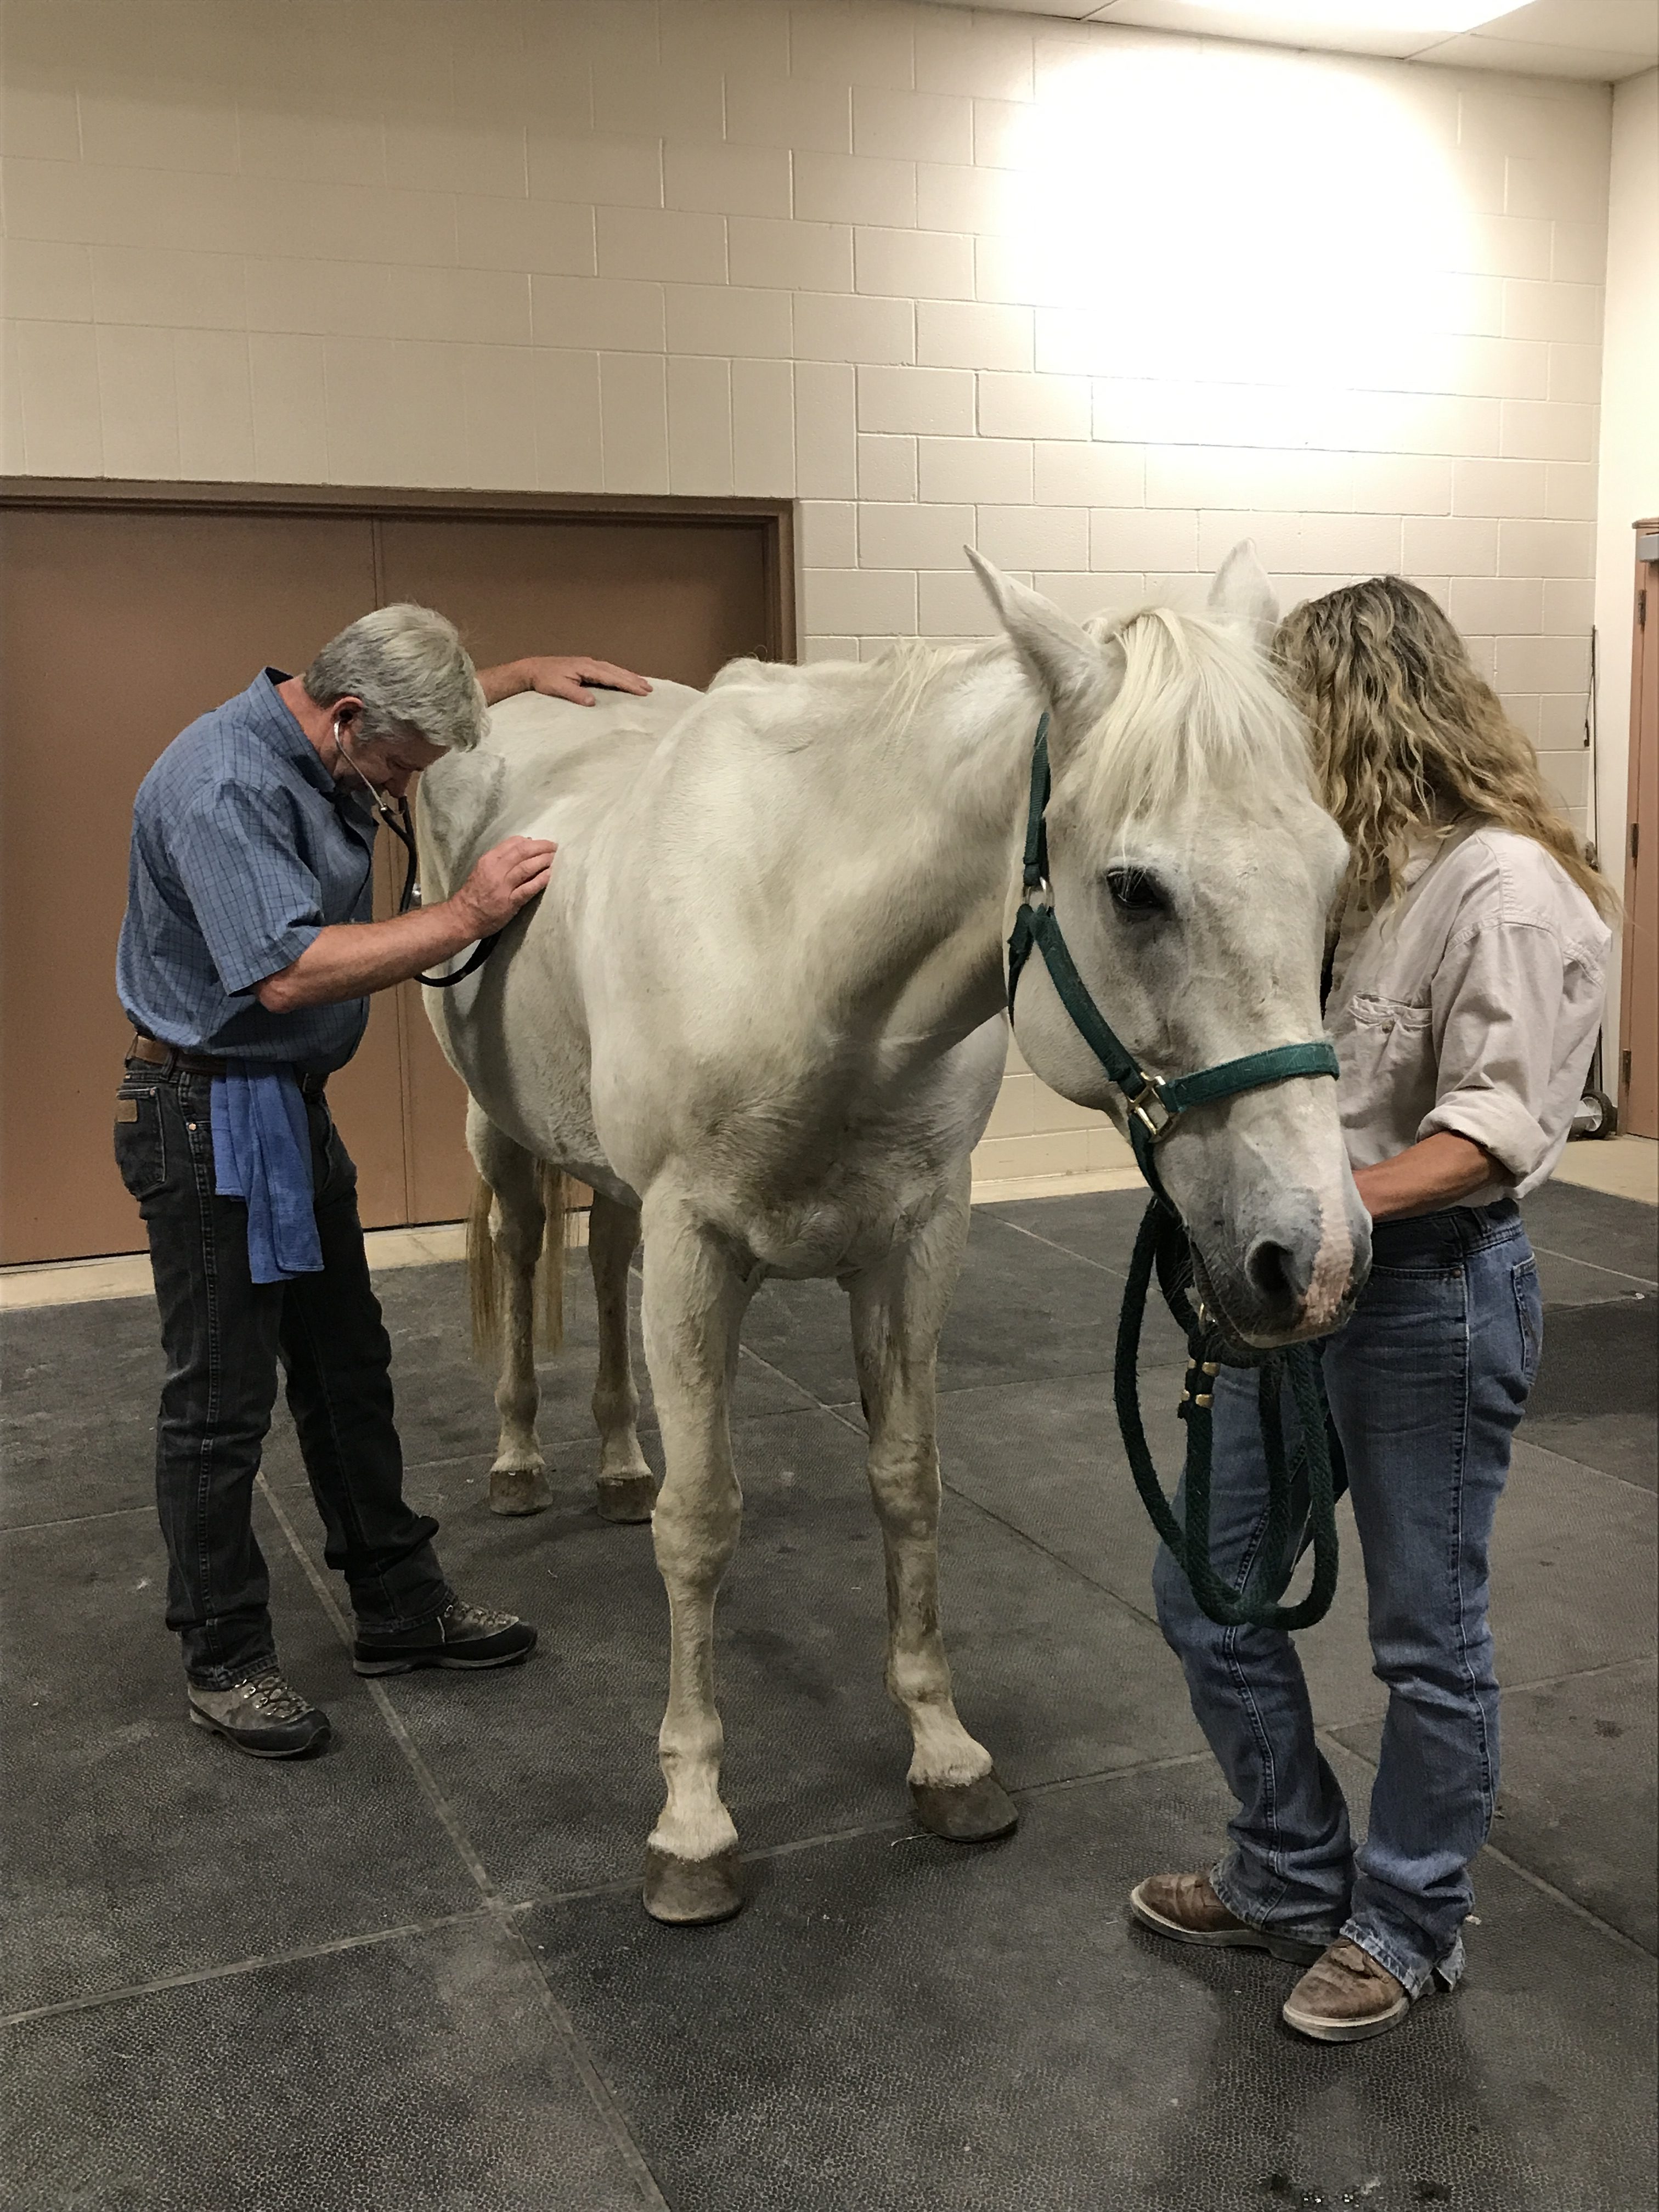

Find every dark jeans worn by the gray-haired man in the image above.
[115,1062,452,1690]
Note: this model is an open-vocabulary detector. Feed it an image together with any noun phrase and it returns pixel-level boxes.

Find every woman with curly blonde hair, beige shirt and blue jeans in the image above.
[1130,575,1612,2042]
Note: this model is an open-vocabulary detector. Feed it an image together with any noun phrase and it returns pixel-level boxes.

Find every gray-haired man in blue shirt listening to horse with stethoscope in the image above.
[115,606,650,1758]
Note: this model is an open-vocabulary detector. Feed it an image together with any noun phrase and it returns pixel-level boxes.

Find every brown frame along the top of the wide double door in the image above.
[0,476,799,662]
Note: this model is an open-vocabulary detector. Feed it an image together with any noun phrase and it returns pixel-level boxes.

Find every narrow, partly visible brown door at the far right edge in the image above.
[1619,522,1659,1137]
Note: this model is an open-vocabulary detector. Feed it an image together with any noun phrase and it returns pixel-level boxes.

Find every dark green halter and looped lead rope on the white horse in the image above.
[1009,714,1347,1628]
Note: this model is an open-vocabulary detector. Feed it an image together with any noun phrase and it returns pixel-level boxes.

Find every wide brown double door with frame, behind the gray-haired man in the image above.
[0,495,787,1263]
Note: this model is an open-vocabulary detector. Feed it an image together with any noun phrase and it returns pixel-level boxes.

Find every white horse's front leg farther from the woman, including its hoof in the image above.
[644,1199,750,1922]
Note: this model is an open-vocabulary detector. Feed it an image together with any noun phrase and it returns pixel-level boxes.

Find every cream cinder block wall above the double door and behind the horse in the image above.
[0,0,1610,1179]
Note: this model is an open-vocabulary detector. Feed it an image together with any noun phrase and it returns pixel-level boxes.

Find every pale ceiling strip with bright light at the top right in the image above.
[929,0,1659,84]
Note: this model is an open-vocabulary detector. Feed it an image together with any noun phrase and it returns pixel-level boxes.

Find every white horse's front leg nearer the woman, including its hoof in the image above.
[847,1164,1020,1843]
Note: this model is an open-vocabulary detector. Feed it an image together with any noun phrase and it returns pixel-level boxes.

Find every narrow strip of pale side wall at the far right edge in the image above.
[1595,69,1659,1070]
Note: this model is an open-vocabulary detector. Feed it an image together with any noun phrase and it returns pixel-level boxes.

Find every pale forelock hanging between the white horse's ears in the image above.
[1073,606,1312,823]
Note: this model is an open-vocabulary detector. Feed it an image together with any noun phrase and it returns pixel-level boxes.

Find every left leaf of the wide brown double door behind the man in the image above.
[0,509,405,1261]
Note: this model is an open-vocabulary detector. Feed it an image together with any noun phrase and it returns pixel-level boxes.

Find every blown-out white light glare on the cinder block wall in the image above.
[1009,47,1469,416]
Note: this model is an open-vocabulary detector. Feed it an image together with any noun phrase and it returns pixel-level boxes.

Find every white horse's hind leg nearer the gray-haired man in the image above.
[467,1106,557,1513]
